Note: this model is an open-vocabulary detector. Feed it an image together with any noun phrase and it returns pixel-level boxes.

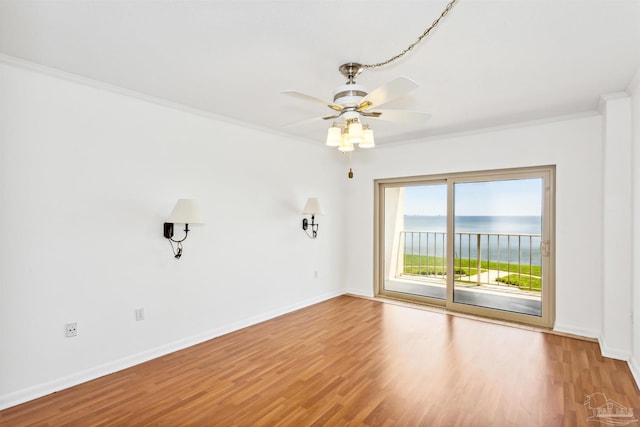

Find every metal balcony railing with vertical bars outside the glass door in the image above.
[397,231,542,292]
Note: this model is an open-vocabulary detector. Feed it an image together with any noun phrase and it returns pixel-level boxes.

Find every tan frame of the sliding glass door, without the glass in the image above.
[374,165,556,328]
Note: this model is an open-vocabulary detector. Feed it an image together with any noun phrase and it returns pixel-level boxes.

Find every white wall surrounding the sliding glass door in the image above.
[346,114,603,337]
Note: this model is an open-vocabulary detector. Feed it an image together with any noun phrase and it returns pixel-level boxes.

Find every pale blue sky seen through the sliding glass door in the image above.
[404,178,542,216]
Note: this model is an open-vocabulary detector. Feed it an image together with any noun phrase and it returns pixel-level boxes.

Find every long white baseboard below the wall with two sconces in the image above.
[0,289,345,410]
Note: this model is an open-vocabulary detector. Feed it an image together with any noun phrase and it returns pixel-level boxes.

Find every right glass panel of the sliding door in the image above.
[453,178,544,317]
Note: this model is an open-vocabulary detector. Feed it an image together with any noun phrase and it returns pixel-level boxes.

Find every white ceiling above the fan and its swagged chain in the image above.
[0,0,640,144]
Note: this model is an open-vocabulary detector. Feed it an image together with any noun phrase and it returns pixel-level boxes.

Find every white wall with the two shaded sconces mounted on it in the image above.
[0,62,345,408]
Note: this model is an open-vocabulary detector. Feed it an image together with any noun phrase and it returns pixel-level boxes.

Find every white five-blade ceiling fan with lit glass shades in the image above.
[282,62,431,151]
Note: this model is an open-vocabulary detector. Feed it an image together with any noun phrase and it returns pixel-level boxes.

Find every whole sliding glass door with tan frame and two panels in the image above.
[376,166,555,327]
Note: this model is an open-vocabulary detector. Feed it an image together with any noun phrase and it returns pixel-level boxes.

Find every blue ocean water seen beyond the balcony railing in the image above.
[404,215,542,265]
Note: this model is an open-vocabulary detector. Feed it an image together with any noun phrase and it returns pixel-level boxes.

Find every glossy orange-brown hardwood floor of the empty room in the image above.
[0,296,640,426]
